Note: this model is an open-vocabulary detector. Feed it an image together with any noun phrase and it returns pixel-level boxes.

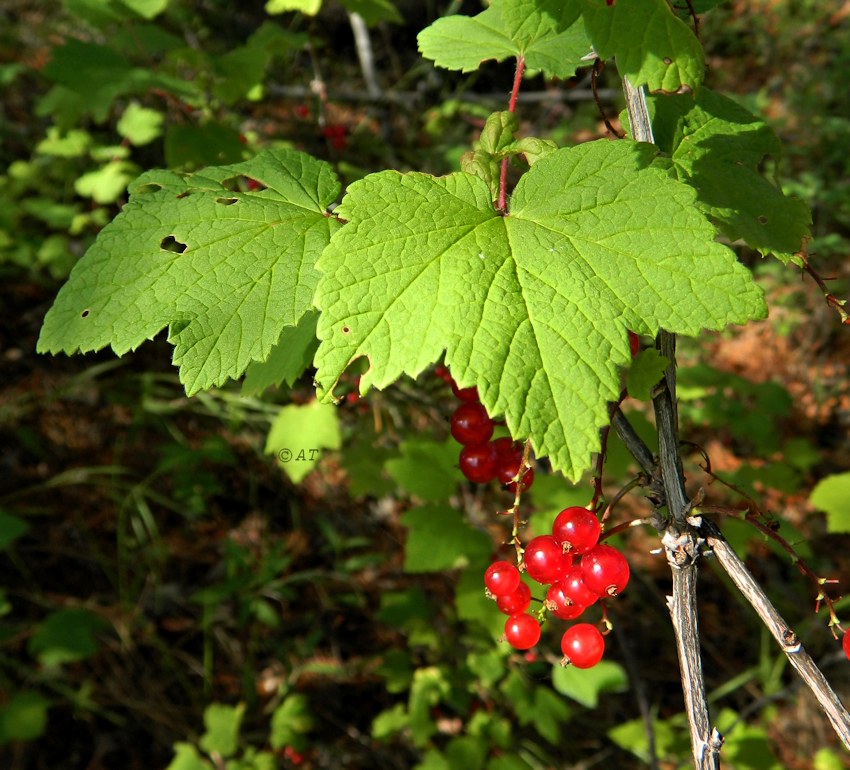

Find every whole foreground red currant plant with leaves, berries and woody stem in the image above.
[31,0,850,767]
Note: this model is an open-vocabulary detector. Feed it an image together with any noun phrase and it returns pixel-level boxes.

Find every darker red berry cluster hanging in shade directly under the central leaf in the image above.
[437,369,534,492]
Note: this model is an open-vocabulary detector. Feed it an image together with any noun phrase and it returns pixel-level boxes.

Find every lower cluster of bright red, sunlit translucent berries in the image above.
[484,507,629,668]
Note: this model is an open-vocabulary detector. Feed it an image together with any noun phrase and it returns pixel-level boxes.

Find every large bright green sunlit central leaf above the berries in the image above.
[315,141,766,479]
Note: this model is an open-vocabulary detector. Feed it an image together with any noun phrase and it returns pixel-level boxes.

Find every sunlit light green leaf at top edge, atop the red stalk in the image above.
[417,0,590,78]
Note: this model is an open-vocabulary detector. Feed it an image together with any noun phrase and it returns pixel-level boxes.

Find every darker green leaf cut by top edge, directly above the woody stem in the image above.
[581,0,705,93]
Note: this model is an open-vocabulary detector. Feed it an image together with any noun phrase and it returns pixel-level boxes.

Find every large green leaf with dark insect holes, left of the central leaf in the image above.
[38,150,339,395]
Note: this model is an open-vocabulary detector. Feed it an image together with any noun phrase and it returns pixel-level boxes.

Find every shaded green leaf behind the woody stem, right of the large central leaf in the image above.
[652,88,811,262]
